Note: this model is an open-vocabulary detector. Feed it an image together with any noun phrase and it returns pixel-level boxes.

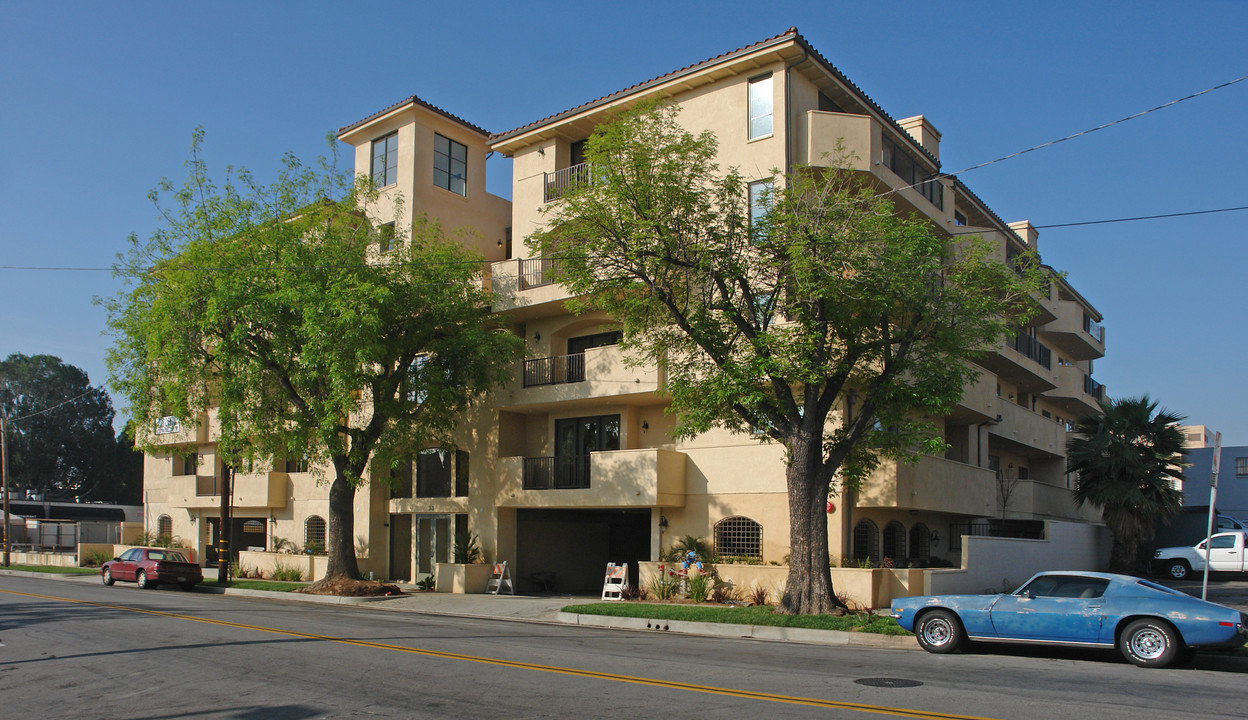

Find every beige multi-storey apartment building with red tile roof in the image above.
[147,29,1104,591]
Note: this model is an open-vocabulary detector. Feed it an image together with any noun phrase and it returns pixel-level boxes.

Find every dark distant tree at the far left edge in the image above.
[0,353,135,502]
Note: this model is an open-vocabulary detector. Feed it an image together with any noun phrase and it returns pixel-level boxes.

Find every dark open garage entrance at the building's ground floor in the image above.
[515,501,650,595]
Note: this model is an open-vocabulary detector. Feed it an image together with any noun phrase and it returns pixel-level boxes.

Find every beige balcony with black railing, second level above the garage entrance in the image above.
[495,346,663,409]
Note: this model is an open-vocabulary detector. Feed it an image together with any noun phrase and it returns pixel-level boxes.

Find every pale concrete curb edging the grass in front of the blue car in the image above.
[558,613,920,650]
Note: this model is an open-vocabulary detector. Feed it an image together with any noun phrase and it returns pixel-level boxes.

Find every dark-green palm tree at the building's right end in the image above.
[1066,394,1183,572]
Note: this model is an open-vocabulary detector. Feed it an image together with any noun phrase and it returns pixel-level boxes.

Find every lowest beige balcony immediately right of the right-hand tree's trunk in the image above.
[856,455,997,517]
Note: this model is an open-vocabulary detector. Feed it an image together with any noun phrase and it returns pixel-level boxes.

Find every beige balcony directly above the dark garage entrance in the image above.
[498,448,685,508]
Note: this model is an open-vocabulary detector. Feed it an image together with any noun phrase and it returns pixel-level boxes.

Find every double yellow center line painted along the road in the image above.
[0,590,992,720]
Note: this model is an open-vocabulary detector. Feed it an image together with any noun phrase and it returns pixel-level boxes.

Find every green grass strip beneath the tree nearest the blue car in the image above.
[563,603,911,635]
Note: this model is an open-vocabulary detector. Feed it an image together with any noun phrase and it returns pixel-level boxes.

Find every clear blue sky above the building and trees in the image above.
[0,0,1248,444]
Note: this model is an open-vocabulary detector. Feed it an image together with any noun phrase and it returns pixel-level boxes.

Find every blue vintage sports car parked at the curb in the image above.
[892,572,1248,668]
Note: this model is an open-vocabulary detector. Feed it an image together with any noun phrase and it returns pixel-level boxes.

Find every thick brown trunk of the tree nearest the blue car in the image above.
[779,429,845,615]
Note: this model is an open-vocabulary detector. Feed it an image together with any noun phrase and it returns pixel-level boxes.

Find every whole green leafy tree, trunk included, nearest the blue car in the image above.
[528,105,1040,614]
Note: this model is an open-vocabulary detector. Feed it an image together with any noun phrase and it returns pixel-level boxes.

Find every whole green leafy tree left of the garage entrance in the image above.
[106,131,520,581]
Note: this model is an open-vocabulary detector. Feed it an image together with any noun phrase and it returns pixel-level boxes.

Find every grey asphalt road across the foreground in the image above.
[0,576,1248,720]
